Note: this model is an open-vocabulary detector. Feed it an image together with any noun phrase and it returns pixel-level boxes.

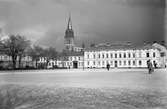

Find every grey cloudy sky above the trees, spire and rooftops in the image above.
[0,0,165,50]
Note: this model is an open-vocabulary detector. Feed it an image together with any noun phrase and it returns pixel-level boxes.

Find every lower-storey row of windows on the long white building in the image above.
[87,60,142,66]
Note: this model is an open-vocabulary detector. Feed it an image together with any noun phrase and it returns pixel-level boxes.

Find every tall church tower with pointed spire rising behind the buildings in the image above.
[64,16,75,51]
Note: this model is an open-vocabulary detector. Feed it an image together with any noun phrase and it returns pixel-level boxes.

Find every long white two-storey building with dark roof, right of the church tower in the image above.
[84,44,163,68]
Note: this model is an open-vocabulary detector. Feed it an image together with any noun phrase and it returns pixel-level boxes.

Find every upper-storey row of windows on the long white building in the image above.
[87,52,156,59]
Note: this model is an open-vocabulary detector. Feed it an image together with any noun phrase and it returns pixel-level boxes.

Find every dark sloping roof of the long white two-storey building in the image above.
[85,43,155,51]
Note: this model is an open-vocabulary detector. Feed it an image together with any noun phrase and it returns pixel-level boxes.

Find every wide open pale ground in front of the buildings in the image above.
[0,69,167,109]
